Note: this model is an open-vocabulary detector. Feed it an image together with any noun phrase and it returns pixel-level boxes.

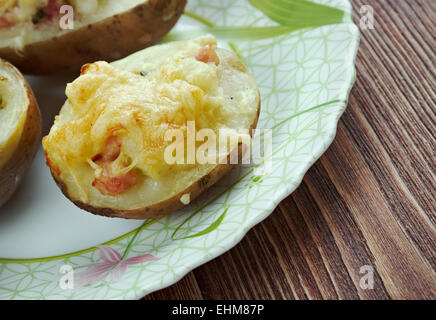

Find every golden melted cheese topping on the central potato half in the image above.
[43,38,231,189]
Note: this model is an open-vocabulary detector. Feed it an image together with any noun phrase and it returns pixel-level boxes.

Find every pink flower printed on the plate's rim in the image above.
[75,246,159,286]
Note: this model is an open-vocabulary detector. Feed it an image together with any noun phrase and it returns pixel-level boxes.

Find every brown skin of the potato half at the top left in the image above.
[0,0,186,74]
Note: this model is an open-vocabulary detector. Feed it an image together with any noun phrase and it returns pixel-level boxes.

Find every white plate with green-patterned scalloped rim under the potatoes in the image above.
[0,0,359,299]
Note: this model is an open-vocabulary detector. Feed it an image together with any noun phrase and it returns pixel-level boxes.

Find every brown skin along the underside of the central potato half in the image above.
[51,99,260,220]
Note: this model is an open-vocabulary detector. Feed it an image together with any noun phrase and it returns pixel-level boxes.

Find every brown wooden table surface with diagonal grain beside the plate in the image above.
[145,0,436,299]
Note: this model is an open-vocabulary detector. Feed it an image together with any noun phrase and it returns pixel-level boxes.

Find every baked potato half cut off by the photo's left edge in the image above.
[0,59,41,207]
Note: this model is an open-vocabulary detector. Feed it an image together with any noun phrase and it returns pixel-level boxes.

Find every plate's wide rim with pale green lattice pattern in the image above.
[0,0,359,299]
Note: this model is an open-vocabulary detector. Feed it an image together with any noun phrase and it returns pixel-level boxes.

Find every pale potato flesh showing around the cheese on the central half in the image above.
[44,36,259,210]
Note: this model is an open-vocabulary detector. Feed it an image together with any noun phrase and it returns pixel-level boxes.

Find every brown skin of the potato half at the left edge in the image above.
[0,62,42,207]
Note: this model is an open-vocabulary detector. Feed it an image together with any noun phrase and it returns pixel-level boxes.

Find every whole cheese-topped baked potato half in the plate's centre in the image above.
[43,35,260,219]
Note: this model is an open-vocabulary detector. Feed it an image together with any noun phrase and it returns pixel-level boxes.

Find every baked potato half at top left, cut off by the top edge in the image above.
[0,0,186,74]
